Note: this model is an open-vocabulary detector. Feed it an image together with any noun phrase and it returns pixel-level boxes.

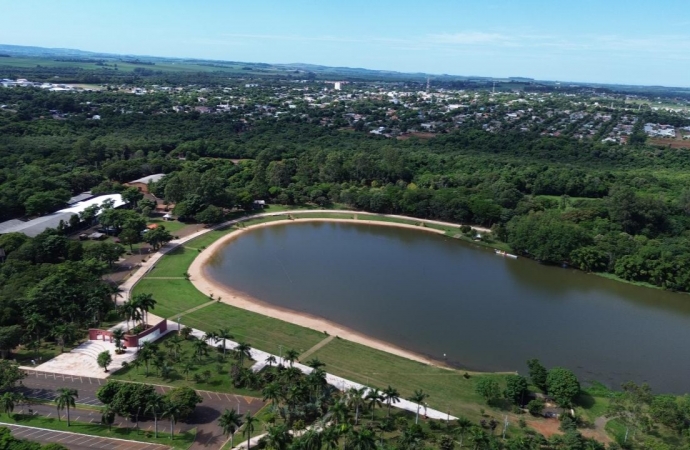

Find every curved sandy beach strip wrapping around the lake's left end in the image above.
[187,217,450,369]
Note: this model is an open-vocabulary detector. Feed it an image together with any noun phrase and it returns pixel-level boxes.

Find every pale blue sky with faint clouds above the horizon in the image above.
[0,0,690,86]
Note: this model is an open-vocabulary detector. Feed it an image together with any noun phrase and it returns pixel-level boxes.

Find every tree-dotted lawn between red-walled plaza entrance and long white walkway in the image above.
[110,334,261,397]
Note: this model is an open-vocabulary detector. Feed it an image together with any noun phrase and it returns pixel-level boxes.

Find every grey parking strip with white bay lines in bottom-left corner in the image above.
[2,424,170,450]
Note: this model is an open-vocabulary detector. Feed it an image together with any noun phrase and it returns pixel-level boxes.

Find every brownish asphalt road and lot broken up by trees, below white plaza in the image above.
[20,371,264,450]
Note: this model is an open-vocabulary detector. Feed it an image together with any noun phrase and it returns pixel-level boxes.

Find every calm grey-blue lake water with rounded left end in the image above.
[208,222,690,393]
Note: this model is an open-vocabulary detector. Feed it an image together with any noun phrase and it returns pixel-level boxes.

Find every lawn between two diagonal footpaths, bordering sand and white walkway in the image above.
[182,303,326,354]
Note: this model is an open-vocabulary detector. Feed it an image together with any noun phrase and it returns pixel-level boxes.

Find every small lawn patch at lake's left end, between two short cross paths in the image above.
[133,278,210,319]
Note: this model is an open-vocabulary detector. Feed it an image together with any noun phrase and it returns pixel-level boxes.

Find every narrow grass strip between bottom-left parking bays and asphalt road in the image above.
[0,414,196,450]
